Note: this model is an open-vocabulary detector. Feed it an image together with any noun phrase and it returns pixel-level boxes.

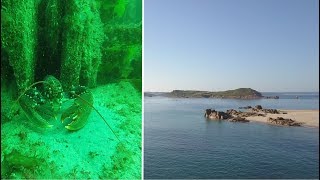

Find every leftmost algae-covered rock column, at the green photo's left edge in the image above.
[1,0,37,92]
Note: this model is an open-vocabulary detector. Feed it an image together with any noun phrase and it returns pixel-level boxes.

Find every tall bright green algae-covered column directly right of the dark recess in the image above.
[60,0,104,89]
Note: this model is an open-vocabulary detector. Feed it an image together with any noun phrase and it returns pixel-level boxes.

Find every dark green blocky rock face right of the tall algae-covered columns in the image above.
[98,23,142,84]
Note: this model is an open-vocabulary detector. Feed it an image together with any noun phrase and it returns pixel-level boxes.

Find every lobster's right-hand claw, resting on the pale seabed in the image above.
[61,92,93,131]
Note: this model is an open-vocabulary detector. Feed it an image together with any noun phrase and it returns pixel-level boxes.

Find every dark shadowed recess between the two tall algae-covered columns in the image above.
[35,0,66,81]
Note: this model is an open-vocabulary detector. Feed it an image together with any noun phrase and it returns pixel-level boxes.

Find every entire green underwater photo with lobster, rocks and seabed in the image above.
[1,0,142,179]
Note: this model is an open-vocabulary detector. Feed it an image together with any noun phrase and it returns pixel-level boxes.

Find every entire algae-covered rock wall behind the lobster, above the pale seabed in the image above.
[1,0,142,94]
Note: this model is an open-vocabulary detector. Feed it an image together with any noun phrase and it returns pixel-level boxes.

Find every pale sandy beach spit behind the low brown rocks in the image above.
[246,110,319,127]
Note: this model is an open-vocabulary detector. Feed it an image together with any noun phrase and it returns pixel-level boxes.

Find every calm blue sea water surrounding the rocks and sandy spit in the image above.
[144,93,319,179]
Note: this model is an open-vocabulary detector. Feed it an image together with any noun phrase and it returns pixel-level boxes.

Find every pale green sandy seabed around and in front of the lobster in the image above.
[1,82,142,179]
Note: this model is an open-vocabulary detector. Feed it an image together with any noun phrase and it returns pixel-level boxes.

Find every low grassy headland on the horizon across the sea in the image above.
[144,88,279,99]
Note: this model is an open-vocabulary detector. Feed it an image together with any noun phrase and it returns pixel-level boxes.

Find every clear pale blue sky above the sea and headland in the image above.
[143,0,319,92]
